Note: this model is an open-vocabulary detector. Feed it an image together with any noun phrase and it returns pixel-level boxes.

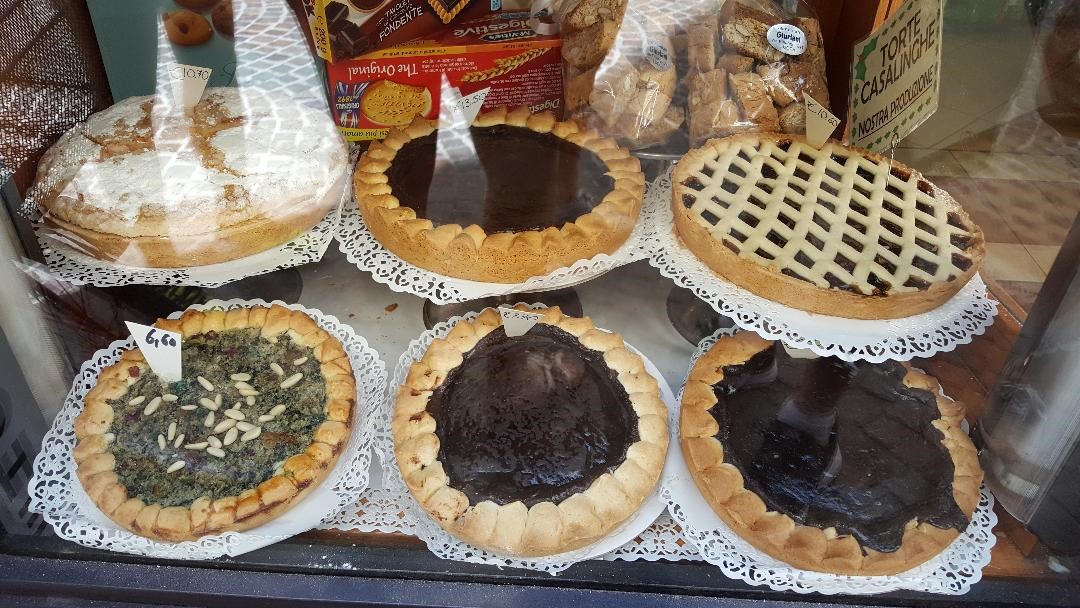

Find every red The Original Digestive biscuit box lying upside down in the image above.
[326,13,563,141]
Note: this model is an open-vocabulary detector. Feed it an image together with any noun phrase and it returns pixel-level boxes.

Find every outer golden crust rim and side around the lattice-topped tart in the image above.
[672,133,986,320]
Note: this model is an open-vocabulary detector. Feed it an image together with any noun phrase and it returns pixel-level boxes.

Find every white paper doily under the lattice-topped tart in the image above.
[646,173,998,363]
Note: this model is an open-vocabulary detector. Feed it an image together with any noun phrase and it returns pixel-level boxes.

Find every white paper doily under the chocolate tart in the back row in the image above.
[337,161,656,305]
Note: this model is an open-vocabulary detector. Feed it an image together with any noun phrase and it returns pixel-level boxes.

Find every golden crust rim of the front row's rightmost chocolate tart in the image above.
[679,332,983,576]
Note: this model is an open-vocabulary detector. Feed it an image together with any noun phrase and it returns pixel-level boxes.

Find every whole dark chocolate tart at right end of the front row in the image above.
[680,332,983,576]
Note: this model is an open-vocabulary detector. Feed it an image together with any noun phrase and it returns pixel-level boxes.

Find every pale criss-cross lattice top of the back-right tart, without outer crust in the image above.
[681,136,981,295]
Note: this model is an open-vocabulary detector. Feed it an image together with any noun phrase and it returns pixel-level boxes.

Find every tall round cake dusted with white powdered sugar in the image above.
[37,87,348,268]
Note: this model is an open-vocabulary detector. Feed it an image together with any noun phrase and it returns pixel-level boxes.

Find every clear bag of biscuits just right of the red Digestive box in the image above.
[561,0,685,148]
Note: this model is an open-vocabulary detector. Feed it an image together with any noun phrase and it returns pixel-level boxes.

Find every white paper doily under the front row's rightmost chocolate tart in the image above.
[661,328,998,595]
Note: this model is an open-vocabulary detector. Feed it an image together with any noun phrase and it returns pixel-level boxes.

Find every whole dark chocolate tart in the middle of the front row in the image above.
[392,308,667,557]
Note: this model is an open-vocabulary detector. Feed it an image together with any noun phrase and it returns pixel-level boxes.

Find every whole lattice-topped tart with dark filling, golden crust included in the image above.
[672,134,985,319]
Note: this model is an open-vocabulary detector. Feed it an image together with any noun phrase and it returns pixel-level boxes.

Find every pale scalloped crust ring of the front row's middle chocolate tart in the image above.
[392,307,667,556]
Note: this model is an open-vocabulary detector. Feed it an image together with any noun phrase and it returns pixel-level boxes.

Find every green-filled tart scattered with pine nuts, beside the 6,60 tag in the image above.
[75,305,356,541]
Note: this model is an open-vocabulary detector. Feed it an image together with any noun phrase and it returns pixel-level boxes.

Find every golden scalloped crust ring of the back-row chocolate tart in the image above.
[353,107,645,283]
